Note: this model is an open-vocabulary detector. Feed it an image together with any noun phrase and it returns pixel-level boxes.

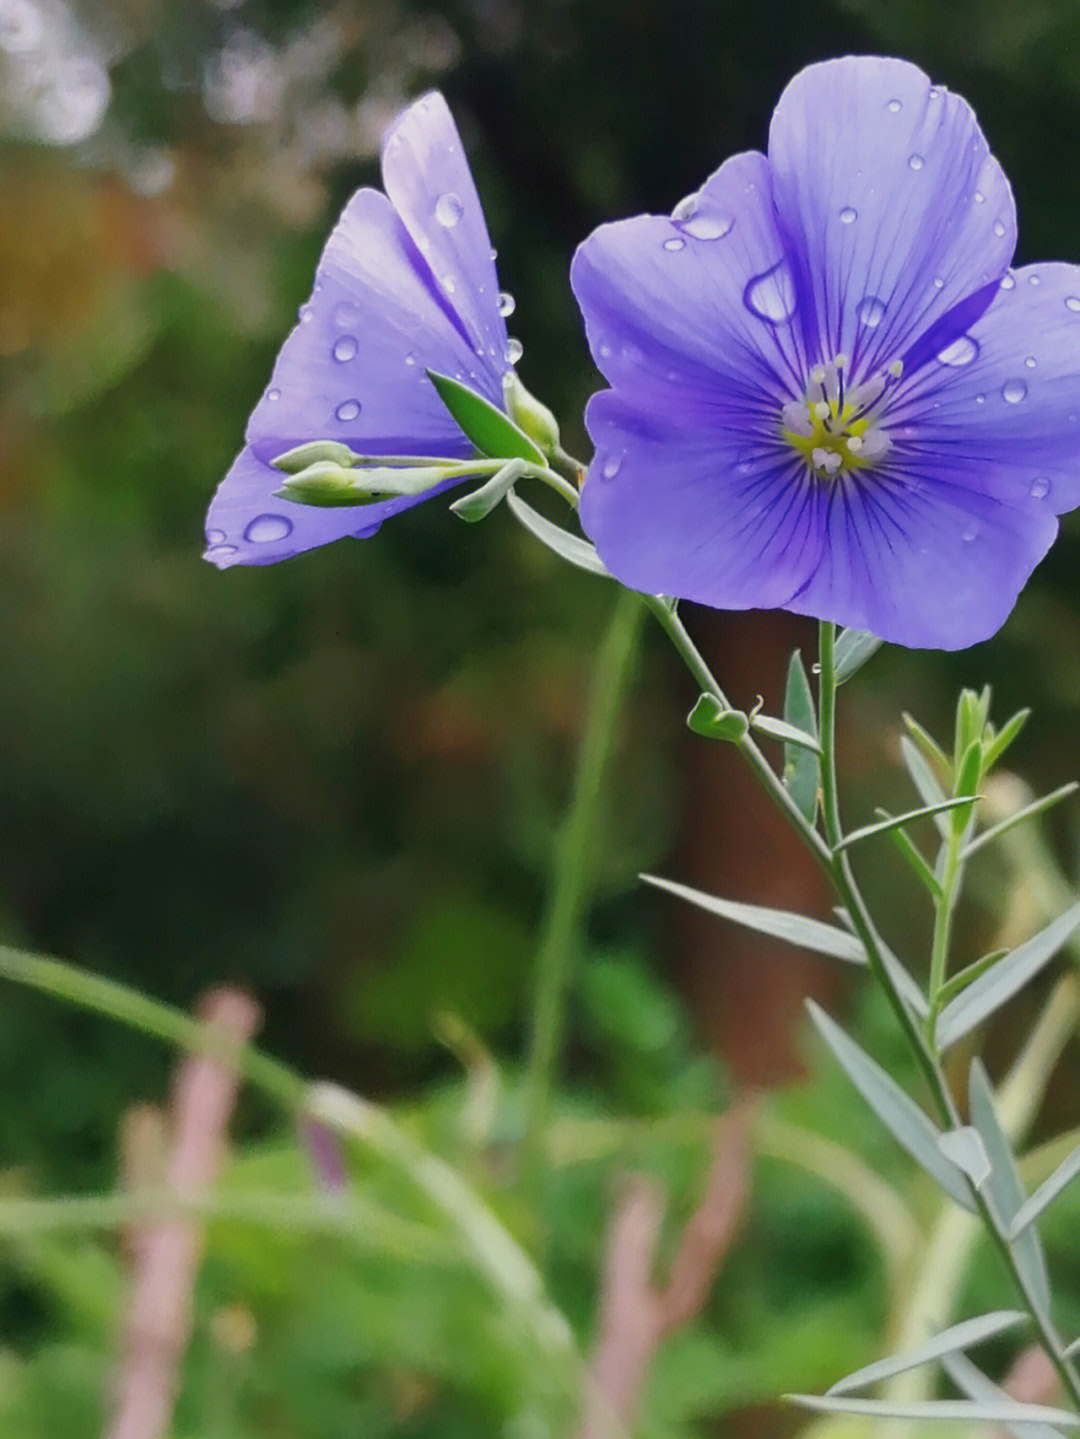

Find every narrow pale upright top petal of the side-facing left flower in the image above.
[383,91,506,371]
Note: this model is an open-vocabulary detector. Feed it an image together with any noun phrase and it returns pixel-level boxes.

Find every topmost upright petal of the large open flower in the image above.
[768,56,1017,374]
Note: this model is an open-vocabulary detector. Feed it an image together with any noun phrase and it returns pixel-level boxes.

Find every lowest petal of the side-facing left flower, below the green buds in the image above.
[203,448,462,570]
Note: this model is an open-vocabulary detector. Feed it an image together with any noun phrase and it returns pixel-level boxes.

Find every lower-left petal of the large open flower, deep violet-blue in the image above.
[581,390,821,610]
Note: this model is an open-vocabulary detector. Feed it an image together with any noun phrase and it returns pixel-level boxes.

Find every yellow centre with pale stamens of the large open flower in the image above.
[781,355,903,479]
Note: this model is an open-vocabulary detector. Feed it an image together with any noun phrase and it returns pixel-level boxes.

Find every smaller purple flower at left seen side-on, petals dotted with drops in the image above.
[206,94,513,568]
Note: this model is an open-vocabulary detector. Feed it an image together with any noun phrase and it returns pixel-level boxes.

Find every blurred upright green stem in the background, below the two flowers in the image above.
[523,590,643,1179]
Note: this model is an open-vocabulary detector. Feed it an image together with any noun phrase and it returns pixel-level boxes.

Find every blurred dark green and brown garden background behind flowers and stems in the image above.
[0,0,1080,1439]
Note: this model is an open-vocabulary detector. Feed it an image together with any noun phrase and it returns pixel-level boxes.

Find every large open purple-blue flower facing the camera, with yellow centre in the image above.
[571,58,1080,649]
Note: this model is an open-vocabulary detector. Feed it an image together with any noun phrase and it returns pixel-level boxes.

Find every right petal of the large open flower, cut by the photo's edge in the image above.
[889,265,1080,514]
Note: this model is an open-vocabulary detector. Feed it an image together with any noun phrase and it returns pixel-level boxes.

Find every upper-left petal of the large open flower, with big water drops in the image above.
[569,151,805,416]
